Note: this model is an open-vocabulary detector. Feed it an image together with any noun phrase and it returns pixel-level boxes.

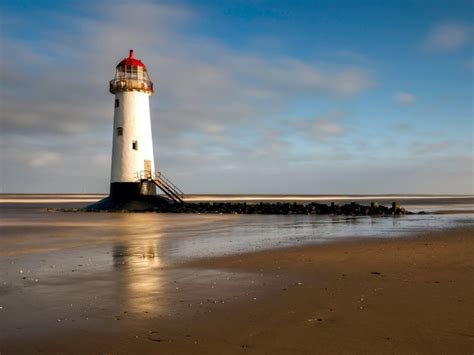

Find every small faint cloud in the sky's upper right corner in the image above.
[427,22,472,51]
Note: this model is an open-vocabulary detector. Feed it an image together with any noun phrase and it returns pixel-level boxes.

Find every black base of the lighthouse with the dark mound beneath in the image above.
[83,182,174,212]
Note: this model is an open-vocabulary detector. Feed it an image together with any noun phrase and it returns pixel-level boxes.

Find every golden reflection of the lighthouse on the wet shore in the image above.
[110,213,167,316]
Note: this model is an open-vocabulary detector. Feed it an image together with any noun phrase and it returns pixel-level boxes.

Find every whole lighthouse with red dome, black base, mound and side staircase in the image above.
[86,50,184,210]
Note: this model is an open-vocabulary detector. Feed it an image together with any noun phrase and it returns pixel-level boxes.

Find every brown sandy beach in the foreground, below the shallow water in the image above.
[0,227,474,355]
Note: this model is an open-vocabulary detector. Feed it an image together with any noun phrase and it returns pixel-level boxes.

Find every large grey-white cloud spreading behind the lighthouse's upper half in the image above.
[1,1,375,142]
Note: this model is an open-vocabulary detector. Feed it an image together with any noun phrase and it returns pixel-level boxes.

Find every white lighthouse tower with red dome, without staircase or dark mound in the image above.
[109,50,155,198]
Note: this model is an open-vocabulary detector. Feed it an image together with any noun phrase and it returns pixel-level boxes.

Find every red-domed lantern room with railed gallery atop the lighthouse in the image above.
[109,49,153,95]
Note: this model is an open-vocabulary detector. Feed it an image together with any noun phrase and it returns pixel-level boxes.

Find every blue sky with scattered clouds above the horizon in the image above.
[0,0,474,194]
